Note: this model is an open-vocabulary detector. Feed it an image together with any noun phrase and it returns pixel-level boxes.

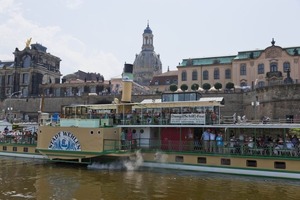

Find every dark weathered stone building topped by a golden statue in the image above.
[0,39,61,99]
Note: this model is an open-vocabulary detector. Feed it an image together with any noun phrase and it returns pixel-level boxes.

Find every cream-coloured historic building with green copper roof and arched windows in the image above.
[177,39,300,90]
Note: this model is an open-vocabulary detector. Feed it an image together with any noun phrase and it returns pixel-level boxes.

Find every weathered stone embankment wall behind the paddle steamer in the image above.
[0,84,300,120]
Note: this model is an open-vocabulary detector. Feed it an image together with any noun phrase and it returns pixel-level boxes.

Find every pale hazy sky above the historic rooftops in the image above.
[0,0,300,80]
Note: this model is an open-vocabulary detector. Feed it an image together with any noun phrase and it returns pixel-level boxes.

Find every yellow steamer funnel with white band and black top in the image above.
[121,63,133,103]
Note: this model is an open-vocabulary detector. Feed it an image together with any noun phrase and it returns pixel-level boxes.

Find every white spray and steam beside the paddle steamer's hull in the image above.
[87,150,144,171]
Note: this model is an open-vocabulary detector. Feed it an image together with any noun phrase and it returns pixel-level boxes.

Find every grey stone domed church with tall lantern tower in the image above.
[133,24,162,86]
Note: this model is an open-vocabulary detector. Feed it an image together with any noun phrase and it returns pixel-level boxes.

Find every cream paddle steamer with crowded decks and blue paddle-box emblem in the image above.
[1,65,300,179]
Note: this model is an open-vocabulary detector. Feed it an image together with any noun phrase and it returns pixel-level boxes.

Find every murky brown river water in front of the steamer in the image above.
[0,157,300,200]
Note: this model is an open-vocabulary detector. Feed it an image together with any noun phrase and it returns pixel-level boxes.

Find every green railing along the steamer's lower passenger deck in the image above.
[104,138,300,159]
